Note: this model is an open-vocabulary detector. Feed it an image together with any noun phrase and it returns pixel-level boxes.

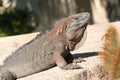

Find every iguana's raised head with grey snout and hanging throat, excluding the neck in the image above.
[65,12,90,50]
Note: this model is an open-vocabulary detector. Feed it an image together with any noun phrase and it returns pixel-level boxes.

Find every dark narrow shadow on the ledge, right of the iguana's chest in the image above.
[73,52,99,58]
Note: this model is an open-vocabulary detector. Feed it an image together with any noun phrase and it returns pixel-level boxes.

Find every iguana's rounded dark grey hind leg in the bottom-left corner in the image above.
[0,65,16,80]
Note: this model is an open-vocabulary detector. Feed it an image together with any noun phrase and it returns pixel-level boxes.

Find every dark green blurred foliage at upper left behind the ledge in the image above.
[0,7,36,36]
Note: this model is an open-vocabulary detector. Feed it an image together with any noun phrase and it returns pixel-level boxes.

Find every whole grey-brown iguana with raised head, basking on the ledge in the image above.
[0,12,90,80]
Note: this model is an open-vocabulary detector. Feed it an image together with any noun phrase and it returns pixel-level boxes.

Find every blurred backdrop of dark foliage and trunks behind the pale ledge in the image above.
[0,0,120,37]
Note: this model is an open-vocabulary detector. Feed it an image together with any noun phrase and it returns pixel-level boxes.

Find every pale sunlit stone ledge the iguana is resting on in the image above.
[0,22,120,80]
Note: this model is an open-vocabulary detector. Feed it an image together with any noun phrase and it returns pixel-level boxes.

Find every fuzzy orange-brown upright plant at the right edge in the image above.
[100,26,120,80]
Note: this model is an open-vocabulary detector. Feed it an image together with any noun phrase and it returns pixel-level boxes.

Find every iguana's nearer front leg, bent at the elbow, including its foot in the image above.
[53,44,82,70]
